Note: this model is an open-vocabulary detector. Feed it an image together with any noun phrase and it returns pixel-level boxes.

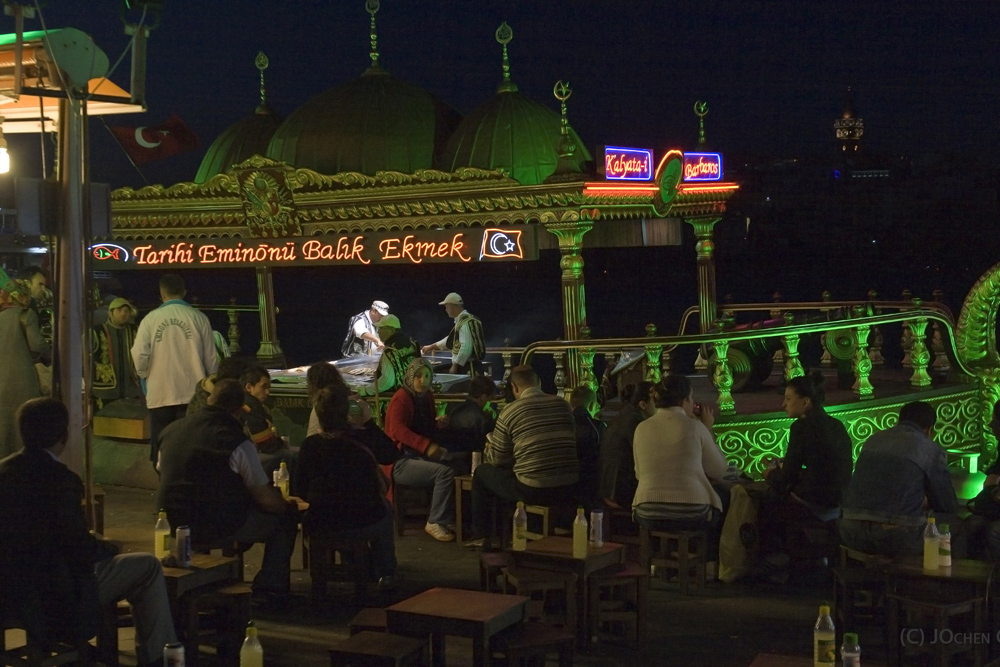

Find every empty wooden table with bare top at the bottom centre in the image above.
[385,588,528,667]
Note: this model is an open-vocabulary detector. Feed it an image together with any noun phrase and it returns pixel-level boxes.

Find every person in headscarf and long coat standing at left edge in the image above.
[0,269,42,459]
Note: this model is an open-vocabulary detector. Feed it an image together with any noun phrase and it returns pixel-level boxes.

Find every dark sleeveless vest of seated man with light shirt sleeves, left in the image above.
[156,405,253,544]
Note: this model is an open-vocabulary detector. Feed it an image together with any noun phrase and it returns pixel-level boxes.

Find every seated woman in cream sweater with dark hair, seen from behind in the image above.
[632,375,727,544]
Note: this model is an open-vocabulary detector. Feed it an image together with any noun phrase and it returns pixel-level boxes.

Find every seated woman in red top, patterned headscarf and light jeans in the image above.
[385,358,455,542]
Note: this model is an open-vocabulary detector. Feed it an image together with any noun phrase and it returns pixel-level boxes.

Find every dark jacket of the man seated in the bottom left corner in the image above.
[0,449,117,646]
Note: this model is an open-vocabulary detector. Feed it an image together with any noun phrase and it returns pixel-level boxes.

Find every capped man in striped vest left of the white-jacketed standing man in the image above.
[90,297,142,404]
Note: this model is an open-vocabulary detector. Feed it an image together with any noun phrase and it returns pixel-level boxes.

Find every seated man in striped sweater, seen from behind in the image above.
[466,366,580,548]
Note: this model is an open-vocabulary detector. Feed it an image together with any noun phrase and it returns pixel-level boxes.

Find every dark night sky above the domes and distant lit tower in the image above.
[4,0,1000,186]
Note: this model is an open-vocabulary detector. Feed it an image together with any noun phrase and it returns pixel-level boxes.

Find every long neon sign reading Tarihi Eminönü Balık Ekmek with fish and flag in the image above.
[90,227,538,271]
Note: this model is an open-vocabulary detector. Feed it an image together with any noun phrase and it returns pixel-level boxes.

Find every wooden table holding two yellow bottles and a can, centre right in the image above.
[507,535,625,646]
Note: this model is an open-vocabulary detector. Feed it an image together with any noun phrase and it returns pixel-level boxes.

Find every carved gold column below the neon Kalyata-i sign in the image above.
[542,217,594,387]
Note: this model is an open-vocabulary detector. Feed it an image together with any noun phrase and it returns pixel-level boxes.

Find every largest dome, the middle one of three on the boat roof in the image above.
[267,66,459,175]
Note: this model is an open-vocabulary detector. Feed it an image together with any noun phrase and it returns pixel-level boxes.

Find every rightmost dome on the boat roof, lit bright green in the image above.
[441,82,591,185]
